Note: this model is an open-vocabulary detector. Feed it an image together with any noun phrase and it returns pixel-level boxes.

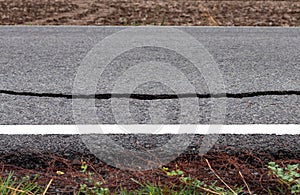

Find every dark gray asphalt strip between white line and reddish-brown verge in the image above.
[0,134,300,170]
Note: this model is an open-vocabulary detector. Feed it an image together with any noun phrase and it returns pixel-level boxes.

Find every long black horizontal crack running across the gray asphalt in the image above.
[0,90,300,100]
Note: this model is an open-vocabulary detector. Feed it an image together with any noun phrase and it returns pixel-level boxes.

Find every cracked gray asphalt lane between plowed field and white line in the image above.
[0,27,300,125]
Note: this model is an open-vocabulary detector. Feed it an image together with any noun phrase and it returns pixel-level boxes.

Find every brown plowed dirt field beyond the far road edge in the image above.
[0,0,300,26]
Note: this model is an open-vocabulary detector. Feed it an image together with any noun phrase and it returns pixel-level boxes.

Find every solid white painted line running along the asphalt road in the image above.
[0,124,300,135]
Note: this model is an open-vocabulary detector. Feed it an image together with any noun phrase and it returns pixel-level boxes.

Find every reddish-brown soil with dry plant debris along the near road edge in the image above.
[0,151,300,195]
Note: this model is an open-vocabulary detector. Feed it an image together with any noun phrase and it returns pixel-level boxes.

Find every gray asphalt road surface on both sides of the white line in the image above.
[0,26,300,166]
